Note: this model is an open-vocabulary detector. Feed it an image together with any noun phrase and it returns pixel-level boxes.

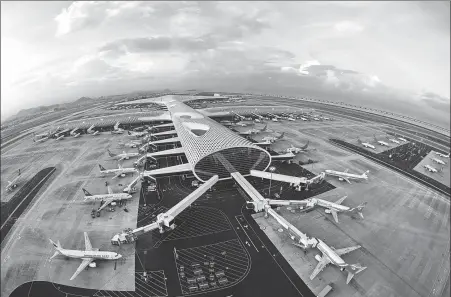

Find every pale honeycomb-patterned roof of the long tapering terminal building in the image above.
[162,95,269,169]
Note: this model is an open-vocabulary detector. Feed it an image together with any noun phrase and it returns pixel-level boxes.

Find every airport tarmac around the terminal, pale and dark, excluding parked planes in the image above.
[1,95,450,297]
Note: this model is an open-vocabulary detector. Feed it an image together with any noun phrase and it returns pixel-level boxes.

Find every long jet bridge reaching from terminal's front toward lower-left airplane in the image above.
[111,175,219,245]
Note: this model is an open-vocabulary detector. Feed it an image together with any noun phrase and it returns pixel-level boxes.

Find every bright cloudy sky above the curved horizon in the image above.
[1,1,450,125]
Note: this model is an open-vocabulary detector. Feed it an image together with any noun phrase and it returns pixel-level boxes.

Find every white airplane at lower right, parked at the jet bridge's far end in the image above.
[306,239,366,284]
